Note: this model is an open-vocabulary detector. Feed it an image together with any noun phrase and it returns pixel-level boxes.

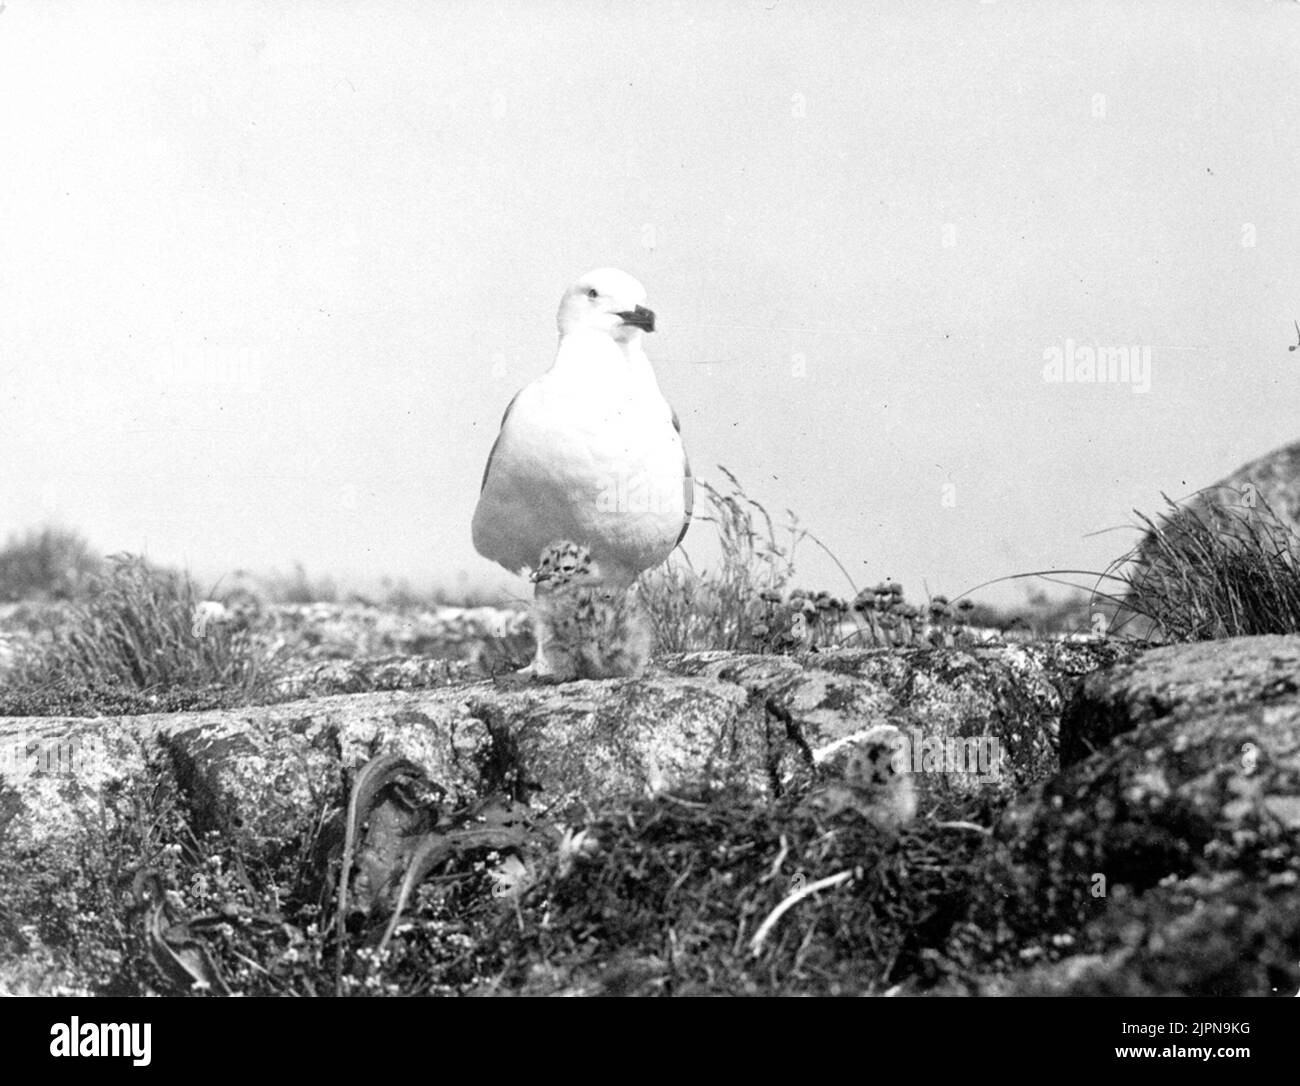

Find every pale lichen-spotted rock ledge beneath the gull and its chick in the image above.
[0,642,1118,868]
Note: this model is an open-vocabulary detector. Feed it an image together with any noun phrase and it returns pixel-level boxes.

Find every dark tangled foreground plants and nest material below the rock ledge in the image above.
[0,757,1013,996]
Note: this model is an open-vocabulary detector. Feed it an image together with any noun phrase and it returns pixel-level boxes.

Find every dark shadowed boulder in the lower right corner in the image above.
[982,637,1300,995]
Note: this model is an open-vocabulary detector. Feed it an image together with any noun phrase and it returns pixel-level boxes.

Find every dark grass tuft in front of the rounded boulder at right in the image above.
[1108,492,1300,641]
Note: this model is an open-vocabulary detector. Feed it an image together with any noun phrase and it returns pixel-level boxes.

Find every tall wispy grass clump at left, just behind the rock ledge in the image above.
[5,554,282,715]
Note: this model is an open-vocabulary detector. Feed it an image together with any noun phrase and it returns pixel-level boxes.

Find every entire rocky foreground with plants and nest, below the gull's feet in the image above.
[0,637,1300,995]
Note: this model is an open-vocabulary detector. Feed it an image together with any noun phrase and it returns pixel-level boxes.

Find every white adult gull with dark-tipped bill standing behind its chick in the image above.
[473,268,694,589]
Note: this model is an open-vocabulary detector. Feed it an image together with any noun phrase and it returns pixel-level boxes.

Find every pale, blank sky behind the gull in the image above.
[0,0,1300,600]
